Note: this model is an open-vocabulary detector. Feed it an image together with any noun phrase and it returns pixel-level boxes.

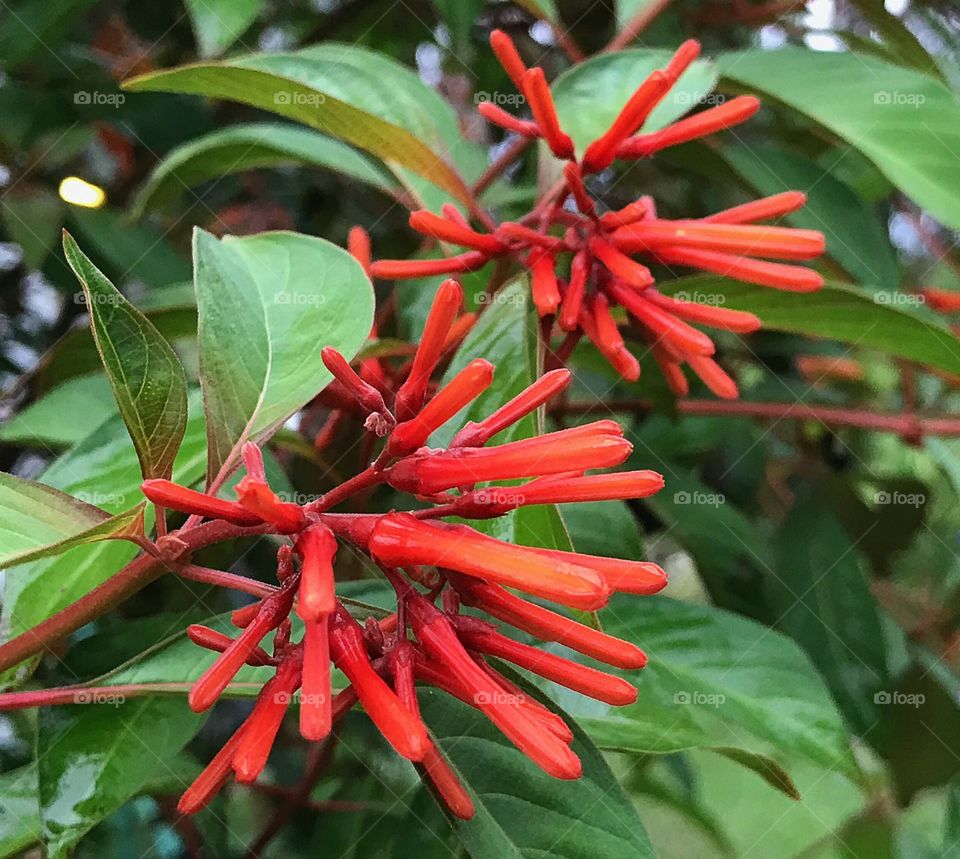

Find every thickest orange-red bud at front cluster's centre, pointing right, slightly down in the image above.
[370,513,609,611]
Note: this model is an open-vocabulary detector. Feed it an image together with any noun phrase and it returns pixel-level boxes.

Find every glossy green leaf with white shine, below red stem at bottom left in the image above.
[37,693,204,859]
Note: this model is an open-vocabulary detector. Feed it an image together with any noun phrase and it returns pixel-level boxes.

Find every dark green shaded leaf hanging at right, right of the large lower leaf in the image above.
[767,491,888,734]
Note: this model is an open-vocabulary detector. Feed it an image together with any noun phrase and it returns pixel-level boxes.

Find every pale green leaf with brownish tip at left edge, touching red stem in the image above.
[0,471,143,568]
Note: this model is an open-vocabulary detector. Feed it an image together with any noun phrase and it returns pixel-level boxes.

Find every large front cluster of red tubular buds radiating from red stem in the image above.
[143,281,666,818]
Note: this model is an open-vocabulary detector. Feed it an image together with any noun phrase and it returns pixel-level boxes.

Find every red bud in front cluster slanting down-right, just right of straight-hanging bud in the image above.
[330,606,430,761]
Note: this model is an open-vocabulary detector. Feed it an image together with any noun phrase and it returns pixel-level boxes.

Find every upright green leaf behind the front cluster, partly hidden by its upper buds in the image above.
[430,279,571,550]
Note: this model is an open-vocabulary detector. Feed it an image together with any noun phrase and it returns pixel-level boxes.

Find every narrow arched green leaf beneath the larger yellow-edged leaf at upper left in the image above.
[133,122,397,218]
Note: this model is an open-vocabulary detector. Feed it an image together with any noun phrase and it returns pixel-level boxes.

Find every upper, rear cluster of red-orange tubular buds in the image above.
[370,31,824,398]
